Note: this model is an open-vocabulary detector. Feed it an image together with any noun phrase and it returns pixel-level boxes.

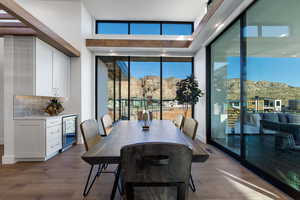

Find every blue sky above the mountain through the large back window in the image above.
[130,62,192,79]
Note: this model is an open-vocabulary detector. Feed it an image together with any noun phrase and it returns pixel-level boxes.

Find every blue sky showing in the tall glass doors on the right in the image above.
[215,57,300,87]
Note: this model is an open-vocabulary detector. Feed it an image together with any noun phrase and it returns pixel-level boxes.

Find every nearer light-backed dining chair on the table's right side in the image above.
[182,118,198,192]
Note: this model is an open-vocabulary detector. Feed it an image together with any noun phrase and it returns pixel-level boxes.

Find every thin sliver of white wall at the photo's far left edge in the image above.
[0,37,4,144]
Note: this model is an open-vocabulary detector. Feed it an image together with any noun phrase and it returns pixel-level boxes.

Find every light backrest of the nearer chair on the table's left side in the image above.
[80,119,101,151]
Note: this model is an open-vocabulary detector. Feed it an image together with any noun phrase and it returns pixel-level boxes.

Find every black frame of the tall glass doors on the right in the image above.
[205,0,300,199]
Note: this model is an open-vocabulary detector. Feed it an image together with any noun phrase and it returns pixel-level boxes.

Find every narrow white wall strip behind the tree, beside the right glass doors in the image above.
[194,48,207,143]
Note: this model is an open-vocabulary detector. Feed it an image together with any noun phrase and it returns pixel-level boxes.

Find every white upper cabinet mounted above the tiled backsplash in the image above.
[14,37,71,97]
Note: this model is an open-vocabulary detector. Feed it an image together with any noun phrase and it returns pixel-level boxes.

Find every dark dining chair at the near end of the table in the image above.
[120,143,192,200]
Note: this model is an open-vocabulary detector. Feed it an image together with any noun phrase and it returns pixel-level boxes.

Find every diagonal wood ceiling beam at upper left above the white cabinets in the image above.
[0,0,80,57]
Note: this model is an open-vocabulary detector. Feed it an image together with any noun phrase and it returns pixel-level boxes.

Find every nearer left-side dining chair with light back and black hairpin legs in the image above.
[80,119,115,196]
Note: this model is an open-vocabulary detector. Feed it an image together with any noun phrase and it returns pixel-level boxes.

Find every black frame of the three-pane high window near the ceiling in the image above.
[95,20,194,35]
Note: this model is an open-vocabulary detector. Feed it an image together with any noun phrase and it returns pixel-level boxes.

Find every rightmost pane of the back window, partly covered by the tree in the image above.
[162,58,193,120]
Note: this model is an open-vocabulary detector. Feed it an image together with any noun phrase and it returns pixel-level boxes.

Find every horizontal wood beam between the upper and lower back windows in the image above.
[86,39,192,48]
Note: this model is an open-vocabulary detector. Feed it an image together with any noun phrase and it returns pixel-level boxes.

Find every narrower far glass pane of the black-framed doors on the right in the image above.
[211,20,241,154]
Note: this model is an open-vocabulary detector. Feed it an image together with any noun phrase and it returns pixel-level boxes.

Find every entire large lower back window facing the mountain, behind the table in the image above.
[96,56,193,121]
